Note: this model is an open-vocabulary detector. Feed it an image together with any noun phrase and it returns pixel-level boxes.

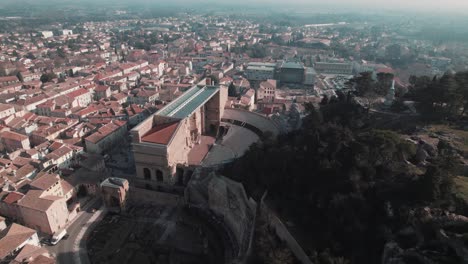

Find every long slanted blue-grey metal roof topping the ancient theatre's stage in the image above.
[156,86,219,119]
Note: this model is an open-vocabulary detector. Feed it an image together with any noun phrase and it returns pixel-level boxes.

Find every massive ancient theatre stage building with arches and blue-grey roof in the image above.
[131,85,227,185]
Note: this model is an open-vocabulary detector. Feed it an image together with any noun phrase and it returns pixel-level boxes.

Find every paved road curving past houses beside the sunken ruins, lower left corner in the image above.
[46,200,102,264]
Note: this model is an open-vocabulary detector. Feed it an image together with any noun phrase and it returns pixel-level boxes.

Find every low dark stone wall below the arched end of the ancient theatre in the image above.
[129,186,184,206]
